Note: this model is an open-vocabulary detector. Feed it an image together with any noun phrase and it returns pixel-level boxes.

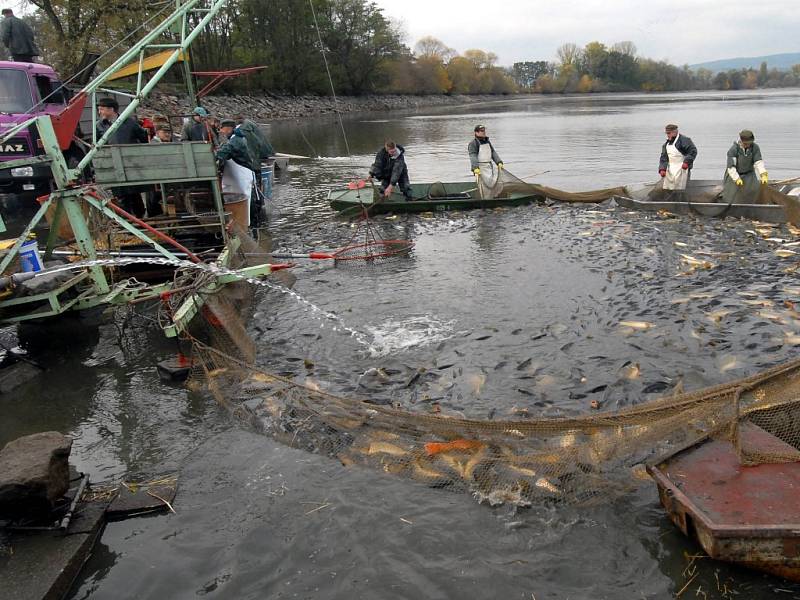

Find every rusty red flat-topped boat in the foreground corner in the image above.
[648,422,800,581]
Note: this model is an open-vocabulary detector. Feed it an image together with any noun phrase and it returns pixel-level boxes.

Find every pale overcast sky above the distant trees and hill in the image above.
[376,0,800,66]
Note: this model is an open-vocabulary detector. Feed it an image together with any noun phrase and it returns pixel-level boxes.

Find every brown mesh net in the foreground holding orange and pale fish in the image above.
[192,332,800,506]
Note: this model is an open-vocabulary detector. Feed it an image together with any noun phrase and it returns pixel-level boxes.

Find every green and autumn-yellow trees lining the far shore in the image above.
[21,0,800,95]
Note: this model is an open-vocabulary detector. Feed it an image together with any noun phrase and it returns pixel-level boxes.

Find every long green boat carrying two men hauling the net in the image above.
[328,181,545,214]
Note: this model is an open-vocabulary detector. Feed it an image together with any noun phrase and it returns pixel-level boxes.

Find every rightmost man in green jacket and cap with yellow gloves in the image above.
[722,129,769,204]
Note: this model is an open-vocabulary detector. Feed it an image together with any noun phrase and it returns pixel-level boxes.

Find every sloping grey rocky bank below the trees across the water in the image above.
[140,93,510,122]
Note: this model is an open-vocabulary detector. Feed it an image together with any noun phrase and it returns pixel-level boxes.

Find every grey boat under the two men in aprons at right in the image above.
[614,179,800,223]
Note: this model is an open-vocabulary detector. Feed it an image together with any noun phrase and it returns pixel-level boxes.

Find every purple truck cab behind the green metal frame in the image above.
[0,61,72,195]
